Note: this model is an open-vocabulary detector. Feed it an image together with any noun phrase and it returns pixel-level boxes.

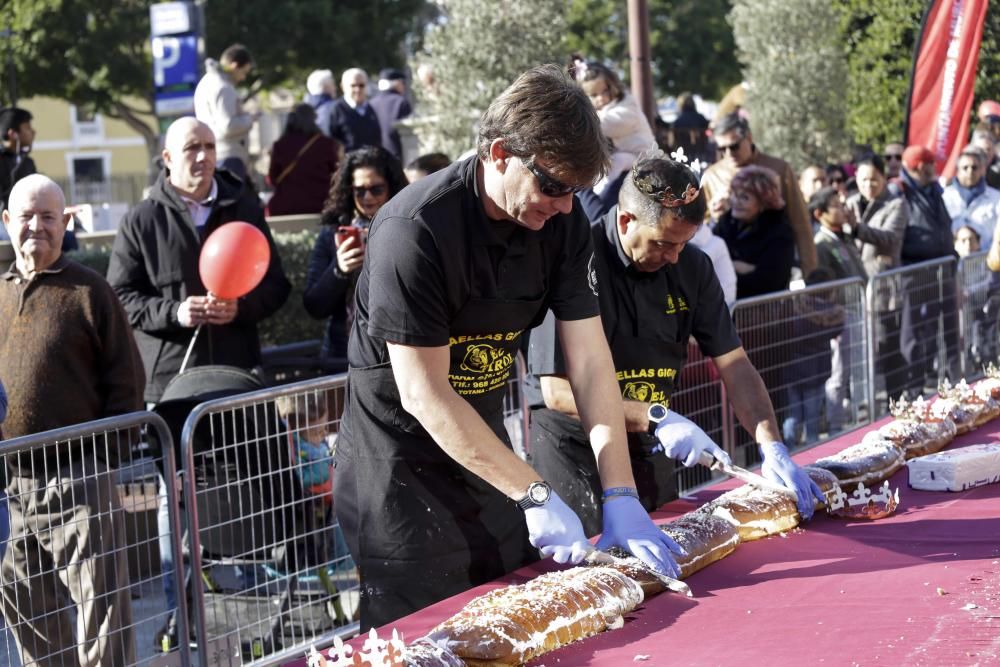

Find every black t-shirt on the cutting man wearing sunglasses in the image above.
[348,157,599,368]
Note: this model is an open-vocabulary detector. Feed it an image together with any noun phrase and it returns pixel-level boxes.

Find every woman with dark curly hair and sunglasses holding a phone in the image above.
[302,146,406,358]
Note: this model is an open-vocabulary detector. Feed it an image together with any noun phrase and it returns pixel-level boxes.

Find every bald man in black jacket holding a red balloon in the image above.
[108,117,291,403]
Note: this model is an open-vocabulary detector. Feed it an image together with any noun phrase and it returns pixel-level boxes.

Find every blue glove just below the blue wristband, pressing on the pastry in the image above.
[597,496,687,579]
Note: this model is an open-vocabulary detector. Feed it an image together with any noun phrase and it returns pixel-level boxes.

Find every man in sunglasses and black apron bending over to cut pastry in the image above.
[334,66,679,631]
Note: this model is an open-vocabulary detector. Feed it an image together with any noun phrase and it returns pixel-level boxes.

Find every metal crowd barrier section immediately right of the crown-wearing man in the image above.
[722,278,872,464]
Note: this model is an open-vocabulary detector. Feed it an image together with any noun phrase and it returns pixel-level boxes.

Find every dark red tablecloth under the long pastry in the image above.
[316,422,1000,667]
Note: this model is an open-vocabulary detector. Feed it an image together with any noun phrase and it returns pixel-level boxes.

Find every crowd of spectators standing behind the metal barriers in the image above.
[0,45,1000,664]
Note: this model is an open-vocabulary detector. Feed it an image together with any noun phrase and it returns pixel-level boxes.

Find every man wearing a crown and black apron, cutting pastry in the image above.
[528,151,822,535]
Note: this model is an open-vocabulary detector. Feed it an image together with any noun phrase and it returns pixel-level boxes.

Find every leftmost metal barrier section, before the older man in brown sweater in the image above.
[0,406,188,667]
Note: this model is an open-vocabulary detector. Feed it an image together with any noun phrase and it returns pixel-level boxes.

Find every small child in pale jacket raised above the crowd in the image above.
[574,60,656,194]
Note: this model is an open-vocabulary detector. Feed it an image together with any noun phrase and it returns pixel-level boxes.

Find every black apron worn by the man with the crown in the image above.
[530,258,691,537]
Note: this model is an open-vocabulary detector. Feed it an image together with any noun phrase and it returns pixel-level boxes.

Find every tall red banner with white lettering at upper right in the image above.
[905,0,989,178]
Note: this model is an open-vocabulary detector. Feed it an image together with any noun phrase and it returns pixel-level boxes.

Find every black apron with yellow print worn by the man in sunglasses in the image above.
[334,288,545,632]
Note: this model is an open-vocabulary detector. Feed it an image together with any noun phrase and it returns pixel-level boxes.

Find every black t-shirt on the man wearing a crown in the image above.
[528,207,741,392]
